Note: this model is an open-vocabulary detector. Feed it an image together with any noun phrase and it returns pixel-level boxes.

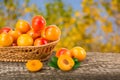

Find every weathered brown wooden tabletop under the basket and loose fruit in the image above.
[0,52,120,80]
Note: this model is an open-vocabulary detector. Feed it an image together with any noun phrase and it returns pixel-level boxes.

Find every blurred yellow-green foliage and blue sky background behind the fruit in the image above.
[0,0,120,52]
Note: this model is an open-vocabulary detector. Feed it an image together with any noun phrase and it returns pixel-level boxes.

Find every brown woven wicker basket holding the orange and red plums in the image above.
[0,40,59,62]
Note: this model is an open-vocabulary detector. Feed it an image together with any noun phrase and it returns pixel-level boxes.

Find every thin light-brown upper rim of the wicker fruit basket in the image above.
[0,38,60,49]
